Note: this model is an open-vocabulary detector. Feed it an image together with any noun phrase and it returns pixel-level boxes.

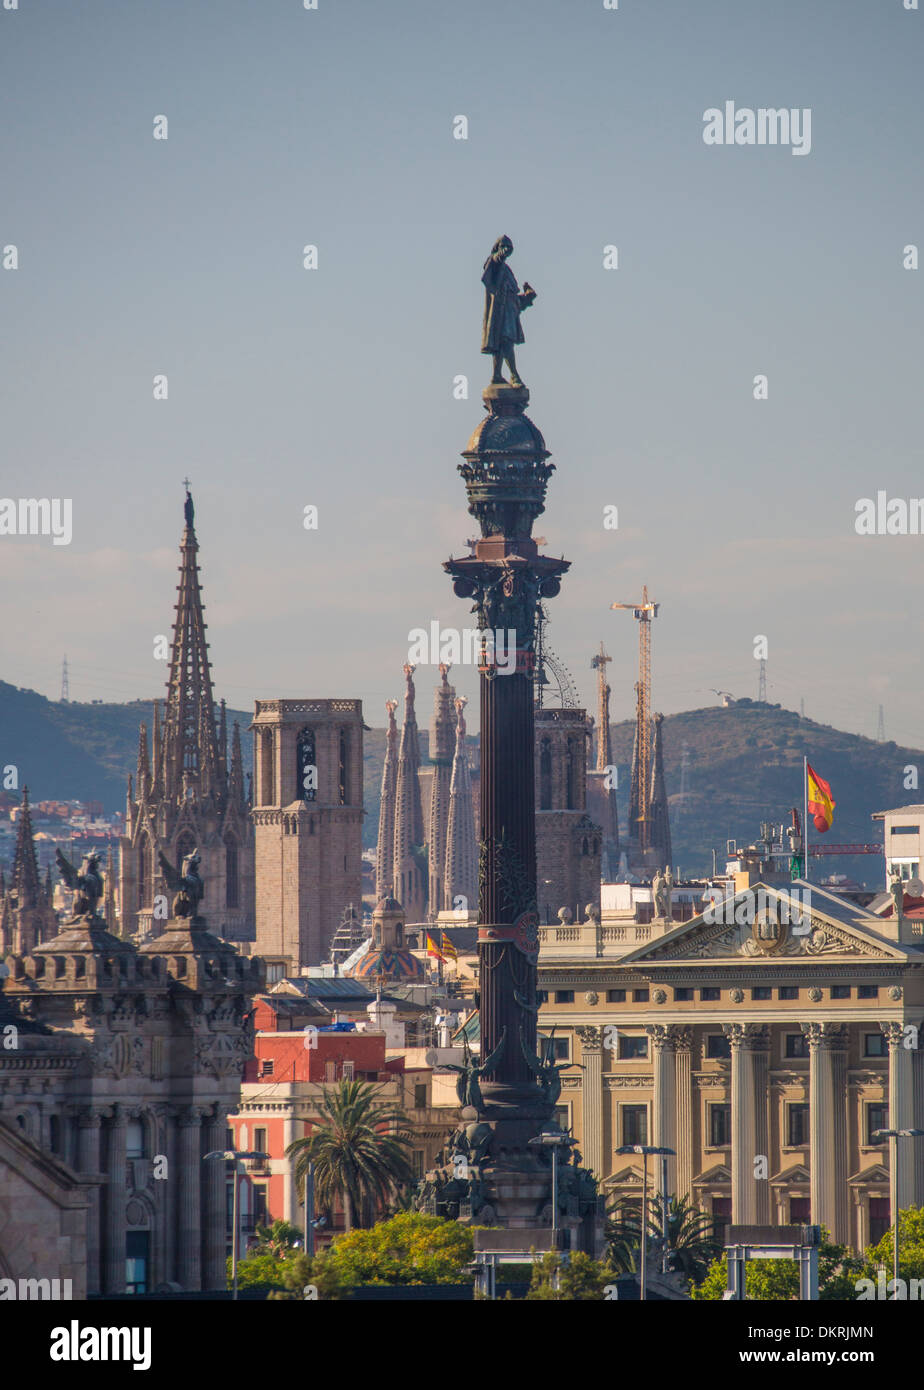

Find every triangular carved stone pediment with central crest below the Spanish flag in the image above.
[621,880,910,965]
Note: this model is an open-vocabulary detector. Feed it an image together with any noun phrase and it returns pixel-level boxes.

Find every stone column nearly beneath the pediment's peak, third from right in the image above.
[723,1023,770,1226]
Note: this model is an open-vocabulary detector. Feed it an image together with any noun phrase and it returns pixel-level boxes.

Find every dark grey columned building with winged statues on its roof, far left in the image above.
[0,895,263,1297]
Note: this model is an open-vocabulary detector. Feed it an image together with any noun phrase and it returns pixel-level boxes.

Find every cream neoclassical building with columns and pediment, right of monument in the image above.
[539,872,924,1248]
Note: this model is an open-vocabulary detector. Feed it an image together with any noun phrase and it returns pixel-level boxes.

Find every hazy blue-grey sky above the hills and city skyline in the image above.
[0,0,924,746]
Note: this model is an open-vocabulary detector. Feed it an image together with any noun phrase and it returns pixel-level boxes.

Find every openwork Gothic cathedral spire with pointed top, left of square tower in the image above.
[119,492,254,941]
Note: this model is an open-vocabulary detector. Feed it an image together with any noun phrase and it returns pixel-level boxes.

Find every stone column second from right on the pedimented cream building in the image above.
[802,1023,849,1241]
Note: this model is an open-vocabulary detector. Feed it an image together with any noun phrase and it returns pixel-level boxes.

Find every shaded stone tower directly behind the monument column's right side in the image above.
[535,709,603,922]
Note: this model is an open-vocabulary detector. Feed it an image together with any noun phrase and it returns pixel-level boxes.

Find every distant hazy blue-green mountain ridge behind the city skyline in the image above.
[0,681,924,884]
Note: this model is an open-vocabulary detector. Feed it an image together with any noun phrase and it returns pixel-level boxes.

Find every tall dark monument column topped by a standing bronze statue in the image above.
[420,236,597,1251]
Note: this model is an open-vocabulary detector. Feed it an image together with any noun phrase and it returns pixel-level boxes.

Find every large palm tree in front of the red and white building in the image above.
[286,1080,414,1230]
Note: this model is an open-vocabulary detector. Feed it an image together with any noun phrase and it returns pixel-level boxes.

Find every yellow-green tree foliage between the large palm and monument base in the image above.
[322,1212,474,1284]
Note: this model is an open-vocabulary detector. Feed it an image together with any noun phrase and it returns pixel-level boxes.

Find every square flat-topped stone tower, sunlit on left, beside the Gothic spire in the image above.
[250,699,363,972]
